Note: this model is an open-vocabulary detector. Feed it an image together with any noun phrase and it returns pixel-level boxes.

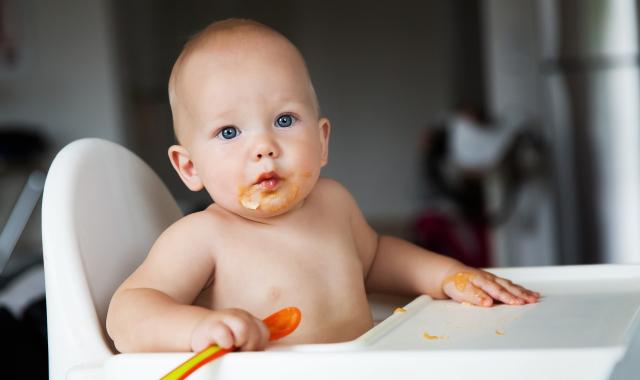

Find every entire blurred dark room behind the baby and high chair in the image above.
[0,0,640,376]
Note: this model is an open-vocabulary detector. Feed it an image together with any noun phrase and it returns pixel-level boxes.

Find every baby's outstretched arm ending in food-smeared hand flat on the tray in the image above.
[345,190,539,306]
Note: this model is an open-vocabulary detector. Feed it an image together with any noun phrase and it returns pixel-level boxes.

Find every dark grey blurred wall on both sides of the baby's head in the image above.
[119,0,482,228]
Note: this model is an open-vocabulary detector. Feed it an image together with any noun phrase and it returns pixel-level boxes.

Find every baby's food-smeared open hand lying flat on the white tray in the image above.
[442,268,540,307]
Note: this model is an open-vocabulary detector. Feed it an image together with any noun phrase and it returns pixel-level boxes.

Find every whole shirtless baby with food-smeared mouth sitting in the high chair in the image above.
[107,20,538,352]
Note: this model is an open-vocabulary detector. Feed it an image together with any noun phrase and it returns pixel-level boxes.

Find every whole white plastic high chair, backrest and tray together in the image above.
[42,139,640,380]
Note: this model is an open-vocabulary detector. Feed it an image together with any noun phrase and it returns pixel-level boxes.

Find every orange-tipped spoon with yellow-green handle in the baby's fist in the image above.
[161,307,302,380]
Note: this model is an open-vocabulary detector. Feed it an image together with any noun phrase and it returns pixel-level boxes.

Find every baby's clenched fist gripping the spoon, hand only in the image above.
[191,309,269,352]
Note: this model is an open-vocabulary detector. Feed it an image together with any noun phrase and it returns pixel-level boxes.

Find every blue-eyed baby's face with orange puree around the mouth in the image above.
[171,37,329,219]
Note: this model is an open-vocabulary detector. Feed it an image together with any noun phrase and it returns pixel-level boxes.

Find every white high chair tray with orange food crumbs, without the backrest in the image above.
[103,265,640,380]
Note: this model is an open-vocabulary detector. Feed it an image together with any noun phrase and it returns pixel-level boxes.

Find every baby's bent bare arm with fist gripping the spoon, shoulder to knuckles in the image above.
[107,215,269,352]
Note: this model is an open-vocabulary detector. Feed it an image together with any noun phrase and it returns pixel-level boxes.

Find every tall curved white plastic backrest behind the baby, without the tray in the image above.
[42,139,181,380]
